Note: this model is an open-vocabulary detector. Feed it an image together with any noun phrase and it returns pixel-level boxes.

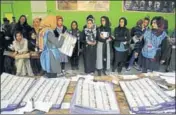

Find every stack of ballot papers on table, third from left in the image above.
[70,78,120,114]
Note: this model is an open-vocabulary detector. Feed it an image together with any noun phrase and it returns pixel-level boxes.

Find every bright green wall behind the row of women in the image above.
[1,1,176,32]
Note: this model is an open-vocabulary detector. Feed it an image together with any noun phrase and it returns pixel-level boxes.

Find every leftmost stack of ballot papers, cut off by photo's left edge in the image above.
[1,73,35,112]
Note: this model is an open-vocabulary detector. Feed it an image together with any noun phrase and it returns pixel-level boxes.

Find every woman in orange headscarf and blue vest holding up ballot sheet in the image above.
[39,16,64,78]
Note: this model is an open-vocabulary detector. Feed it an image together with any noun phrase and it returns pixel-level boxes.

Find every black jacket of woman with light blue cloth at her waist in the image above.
[114,27,131,49]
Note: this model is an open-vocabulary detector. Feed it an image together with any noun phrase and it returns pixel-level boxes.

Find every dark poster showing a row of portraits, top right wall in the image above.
[123,0,175,13]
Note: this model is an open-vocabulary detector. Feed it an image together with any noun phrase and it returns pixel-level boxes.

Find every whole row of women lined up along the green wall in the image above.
[0,15,175,78]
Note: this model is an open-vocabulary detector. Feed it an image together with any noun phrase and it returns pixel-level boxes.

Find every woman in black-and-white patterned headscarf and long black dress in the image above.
[81,18,97,74]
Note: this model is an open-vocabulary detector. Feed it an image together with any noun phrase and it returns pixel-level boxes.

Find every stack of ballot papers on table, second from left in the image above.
[22,77,70,112]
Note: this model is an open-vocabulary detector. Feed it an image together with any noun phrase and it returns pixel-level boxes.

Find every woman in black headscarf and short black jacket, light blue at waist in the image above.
[112,17,130,73]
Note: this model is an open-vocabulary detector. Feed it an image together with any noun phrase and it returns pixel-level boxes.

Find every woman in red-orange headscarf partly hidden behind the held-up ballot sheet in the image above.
[54,16,68,75]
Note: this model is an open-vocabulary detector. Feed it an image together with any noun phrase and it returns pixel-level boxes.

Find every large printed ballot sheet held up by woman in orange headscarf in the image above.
[58,32,77,57]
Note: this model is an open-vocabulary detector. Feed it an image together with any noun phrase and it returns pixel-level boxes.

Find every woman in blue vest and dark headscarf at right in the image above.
[139,16,169,72]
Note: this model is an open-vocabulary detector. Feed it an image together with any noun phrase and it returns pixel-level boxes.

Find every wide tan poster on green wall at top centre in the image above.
[56,0,109,11]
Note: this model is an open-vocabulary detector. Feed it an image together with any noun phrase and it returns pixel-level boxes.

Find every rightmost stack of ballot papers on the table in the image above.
[119,78,175,114]
